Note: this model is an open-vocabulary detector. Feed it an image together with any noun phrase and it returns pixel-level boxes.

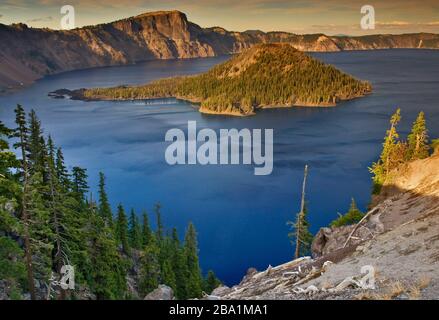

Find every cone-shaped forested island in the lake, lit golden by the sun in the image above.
[73,43,371,115]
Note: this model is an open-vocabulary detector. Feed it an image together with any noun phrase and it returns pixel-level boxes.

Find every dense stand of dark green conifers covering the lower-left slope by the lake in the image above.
[0,106,218,299]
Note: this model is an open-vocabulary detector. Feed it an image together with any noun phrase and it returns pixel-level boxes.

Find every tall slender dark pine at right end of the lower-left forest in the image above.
[184,223,202,298]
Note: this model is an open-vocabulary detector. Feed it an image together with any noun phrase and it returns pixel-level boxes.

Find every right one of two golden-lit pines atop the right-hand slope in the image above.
[406,112,430,161]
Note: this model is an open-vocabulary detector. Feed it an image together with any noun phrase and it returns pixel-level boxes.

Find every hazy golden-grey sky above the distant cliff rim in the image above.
[0,0,439,35]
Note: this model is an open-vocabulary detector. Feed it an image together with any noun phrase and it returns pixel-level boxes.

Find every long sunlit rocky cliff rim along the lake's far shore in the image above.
[0,11,439,92]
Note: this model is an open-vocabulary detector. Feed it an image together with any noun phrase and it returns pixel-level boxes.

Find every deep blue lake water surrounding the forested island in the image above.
[0,50,439,284]
